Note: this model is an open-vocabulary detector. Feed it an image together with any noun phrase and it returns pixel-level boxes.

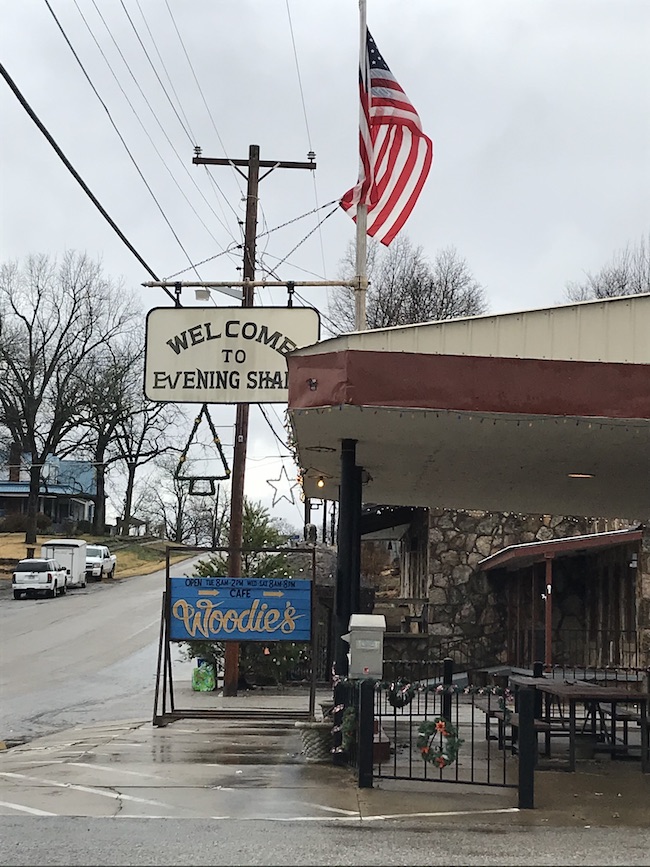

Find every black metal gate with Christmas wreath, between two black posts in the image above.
[334,659,535,806]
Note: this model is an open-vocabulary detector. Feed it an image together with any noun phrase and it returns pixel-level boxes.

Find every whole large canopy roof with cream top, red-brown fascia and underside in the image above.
[288,294,650,521]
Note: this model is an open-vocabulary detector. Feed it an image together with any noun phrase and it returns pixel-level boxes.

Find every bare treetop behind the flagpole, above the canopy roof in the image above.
[329,236,487,333]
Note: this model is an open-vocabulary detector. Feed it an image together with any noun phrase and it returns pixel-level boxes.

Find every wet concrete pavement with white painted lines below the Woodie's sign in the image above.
[0,684,650,827]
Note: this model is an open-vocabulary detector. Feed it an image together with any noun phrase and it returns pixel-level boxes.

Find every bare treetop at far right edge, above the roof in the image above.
[566,235,650,301]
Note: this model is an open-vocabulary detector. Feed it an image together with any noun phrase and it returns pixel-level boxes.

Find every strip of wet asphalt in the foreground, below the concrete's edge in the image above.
[0,817,650,867]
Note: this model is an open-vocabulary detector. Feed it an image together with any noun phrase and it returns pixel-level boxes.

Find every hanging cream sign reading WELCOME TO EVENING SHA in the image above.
[144,307,320,403]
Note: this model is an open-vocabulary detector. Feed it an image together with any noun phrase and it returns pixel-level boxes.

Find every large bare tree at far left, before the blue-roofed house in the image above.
[0,252,139,544]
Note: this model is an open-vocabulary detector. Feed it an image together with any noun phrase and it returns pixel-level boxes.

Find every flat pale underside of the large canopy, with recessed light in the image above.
[292,406,650,520]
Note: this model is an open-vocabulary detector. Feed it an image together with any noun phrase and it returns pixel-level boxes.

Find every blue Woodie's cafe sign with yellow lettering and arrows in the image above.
[169,577,311,641]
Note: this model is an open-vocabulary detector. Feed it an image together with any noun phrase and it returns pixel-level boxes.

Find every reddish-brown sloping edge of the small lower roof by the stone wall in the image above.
[478,527,643,572]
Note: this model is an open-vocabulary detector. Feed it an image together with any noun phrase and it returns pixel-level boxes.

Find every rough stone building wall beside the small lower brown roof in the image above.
[427,509,592,666]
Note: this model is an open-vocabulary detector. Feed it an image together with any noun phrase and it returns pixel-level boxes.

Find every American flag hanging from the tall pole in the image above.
[340,30,433,245]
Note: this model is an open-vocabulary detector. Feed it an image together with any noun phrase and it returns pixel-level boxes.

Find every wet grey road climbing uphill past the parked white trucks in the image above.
[0,561,199,744]
